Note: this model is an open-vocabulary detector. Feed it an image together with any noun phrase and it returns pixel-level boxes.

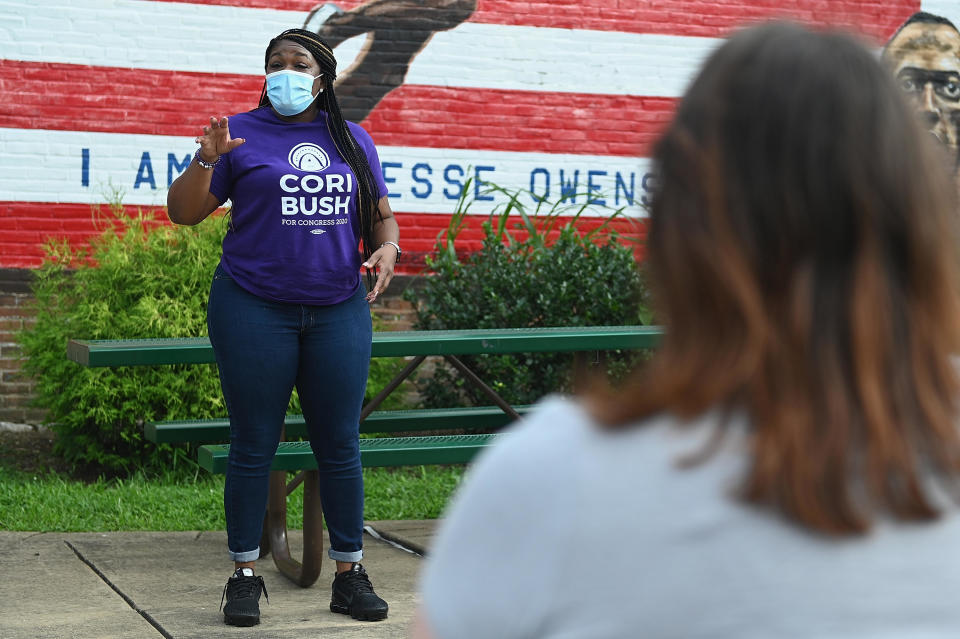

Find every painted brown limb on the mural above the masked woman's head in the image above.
[304,0,477,122]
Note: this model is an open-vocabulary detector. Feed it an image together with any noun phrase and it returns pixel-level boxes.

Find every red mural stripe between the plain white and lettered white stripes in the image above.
[0,60,676,157]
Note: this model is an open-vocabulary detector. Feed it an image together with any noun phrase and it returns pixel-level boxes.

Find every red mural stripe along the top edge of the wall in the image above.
[146,0,920,41]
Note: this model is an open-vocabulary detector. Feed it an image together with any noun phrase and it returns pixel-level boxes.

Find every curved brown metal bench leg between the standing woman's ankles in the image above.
[261,470,323,588]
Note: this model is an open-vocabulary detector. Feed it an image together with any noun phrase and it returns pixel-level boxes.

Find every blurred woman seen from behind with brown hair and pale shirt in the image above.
[418,24,960,639]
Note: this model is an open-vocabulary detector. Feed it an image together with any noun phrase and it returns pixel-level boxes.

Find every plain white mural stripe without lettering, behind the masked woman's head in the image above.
[0,0,721,97]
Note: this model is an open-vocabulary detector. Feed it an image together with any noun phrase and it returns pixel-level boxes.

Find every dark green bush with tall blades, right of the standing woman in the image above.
[406,184,648,406]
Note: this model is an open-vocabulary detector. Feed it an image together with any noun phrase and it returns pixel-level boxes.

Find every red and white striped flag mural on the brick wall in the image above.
[0,0,960,268]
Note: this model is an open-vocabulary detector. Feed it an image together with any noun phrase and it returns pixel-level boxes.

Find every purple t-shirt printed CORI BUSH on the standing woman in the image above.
[210,107,387,305]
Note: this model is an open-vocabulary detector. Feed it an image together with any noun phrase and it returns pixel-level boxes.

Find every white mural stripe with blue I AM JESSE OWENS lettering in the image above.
[0,129,651,216]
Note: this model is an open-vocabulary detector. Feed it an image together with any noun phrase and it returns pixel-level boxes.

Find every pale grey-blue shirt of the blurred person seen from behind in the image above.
[422,397,960,639]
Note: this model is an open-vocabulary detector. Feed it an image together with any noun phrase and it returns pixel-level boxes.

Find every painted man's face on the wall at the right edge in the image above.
[883,13,960,157]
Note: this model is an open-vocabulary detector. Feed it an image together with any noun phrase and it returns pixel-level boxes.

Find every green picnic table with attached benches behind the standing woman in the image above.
[67,326,662,587]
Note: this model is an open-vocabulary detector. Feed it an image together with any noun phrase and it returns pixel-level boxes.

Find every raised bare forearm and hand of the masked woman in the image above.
[167,117,246,226]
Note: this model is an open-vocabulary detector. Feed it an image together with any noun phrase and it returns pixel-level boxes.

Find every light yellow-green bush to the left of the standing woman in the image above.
[20,205,402,475]
